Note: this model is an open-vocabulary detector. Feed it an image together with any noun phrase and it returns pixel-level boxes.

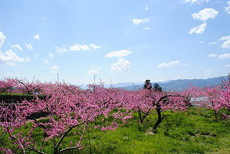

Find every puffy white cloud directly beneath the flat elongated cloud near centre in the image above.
[111,58,131,72]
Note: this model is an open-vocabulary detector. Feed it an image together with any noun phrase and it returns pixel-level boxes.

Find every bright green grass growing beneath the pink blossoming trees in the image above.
[0,108,230,154]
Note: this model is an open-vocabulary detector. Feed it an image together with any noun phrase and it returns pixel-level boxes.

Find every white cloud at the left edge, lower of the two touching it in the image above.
[0,50,30,65]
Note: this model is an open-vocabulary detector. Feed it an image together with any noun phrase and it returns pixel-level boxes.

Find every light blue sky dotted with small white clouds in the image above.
[0,0,230,84]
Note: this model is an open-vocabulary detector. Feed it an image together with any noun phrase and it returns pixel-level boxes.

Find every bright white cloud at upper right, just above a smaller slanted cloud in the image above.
[192,8,218,22]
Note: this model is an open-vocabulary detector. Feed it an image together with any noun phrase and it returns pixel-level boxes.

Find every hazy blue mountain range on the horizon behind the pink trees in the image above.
[115,76,227,91]
